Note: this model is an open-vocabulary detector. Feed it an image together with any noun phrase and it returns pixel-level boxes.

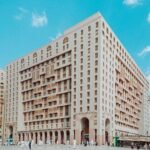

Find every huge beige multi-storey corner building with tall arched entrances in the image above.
[5,13,149,144]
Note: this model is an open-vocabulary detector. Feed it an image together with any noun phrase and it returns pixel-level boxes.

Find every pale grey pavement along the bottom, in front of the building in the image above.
[0,145,134,150]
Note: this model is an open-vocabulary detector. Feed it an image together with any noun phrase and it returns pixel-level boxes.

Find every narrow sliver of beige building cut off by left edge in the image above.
[0,70,5,140]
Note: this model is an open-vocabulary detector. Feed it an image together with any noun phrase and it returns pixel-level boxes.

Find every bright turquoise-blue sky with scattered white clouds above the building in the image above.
[0,0,150,79]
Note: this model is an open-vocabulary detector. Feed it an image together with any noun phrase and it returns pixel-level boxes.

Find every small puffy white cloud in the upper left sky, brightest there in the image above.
[32,12,48,28]
